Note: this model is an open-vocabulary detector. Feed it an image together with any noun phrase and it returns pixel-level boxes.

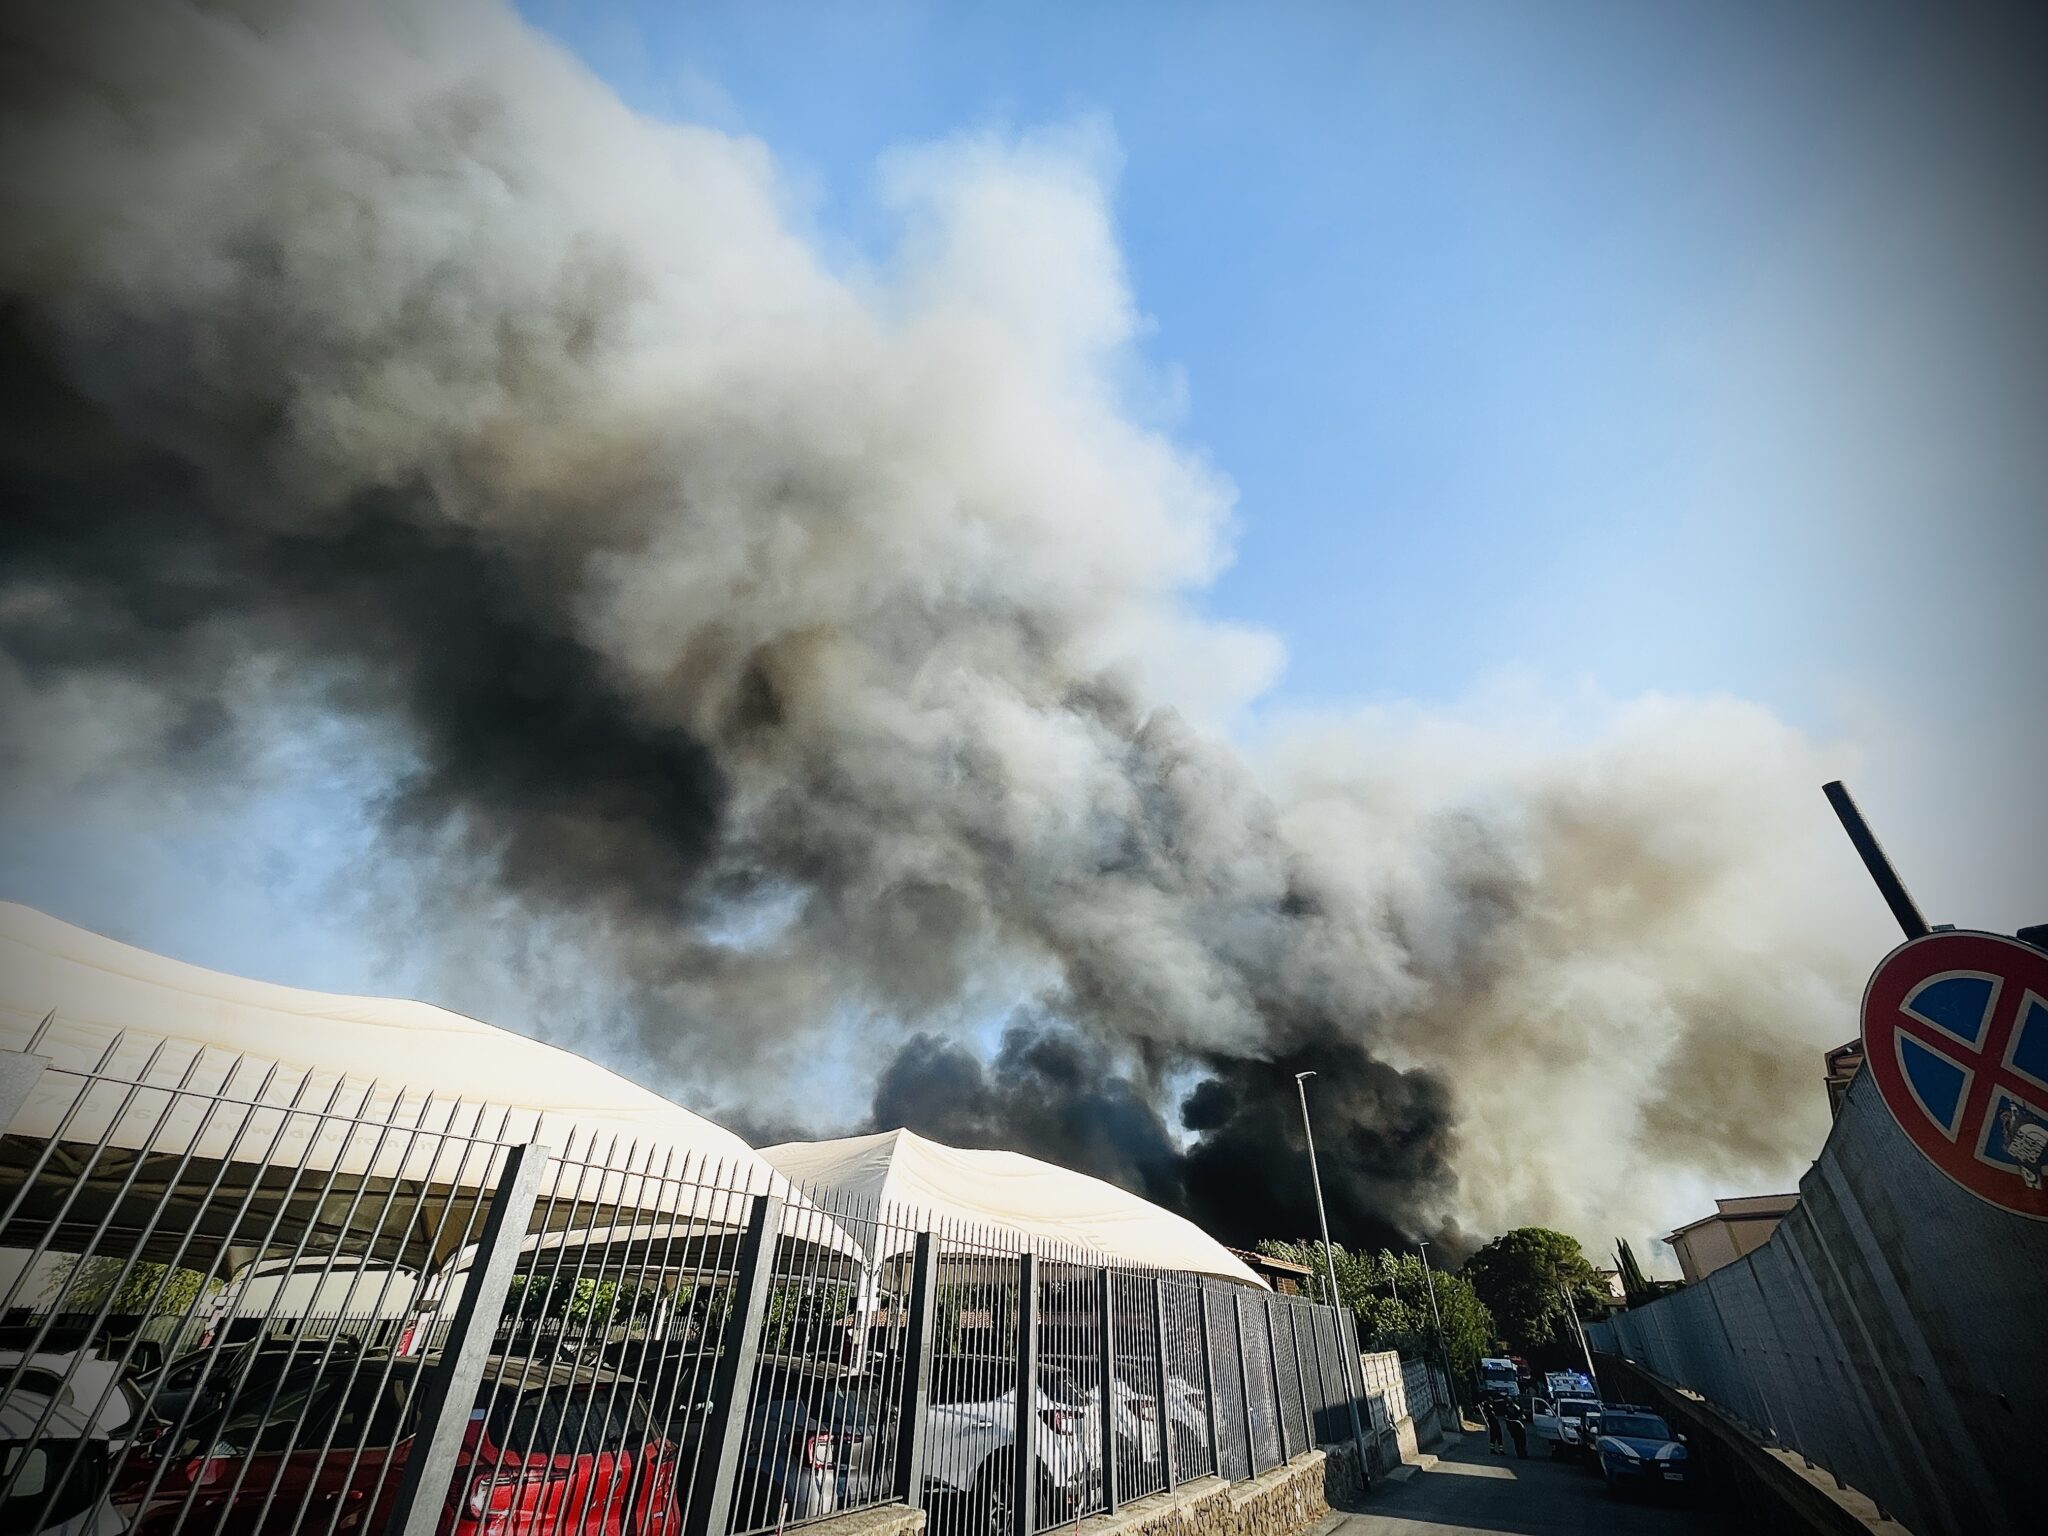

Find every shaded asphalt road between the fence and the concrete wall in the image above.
[1323,1432,1739,1536]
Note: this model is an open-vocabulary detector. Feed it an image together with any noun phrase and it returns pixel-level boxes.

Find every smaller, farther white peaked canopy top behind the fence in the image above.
[762,1130,1266,1290]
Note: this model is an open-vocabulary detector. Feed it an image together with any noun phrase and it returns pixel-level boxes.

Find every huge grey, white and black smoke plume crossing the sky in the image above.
[0,0,1853,1243]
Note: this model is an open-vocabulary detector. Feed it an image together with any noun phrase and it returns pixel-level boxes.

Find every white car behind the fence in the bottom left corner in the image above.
[0,1350,137,1536]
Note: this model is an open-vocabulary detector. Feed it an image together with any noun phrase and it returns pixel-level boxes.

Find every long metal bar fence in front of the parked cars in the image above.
[0,1040,1362,1536]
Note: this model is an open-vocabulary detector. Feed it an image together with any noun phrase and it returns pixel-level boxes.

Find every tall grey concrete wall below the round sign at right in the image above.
[1587,1073,2048,1536]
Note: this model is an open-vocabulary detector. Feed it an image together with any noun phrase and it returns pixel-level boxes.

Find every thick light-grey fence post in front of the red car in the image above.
[380,1143,547,1536]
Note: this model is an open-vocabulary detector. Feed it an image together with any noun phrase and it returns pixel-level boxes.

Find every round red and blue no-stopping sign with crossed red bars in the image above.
[1864,932,2048,1221]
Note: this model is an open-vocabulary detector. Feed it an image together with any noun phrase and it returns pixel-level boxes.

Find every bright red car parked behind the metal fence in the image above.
[113,1348,682,1536]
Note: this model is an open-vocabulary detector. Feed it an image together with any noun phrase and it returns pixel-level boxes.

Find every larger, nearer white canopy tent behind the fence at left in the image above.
[0,903,858,1266]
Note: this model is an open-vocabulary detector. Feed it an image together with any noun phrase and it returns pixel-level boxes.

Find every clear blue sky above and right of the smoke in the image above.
[528,4,2031,745]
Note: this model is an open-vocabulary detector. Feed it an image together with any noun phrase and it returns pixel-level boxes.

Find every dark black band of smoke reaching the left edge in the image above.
[0,311,727,922]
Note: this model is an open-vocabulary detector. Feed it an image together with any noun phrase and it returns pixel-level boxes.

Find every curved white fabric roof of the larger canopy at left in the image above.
[0,901,848,1247]
